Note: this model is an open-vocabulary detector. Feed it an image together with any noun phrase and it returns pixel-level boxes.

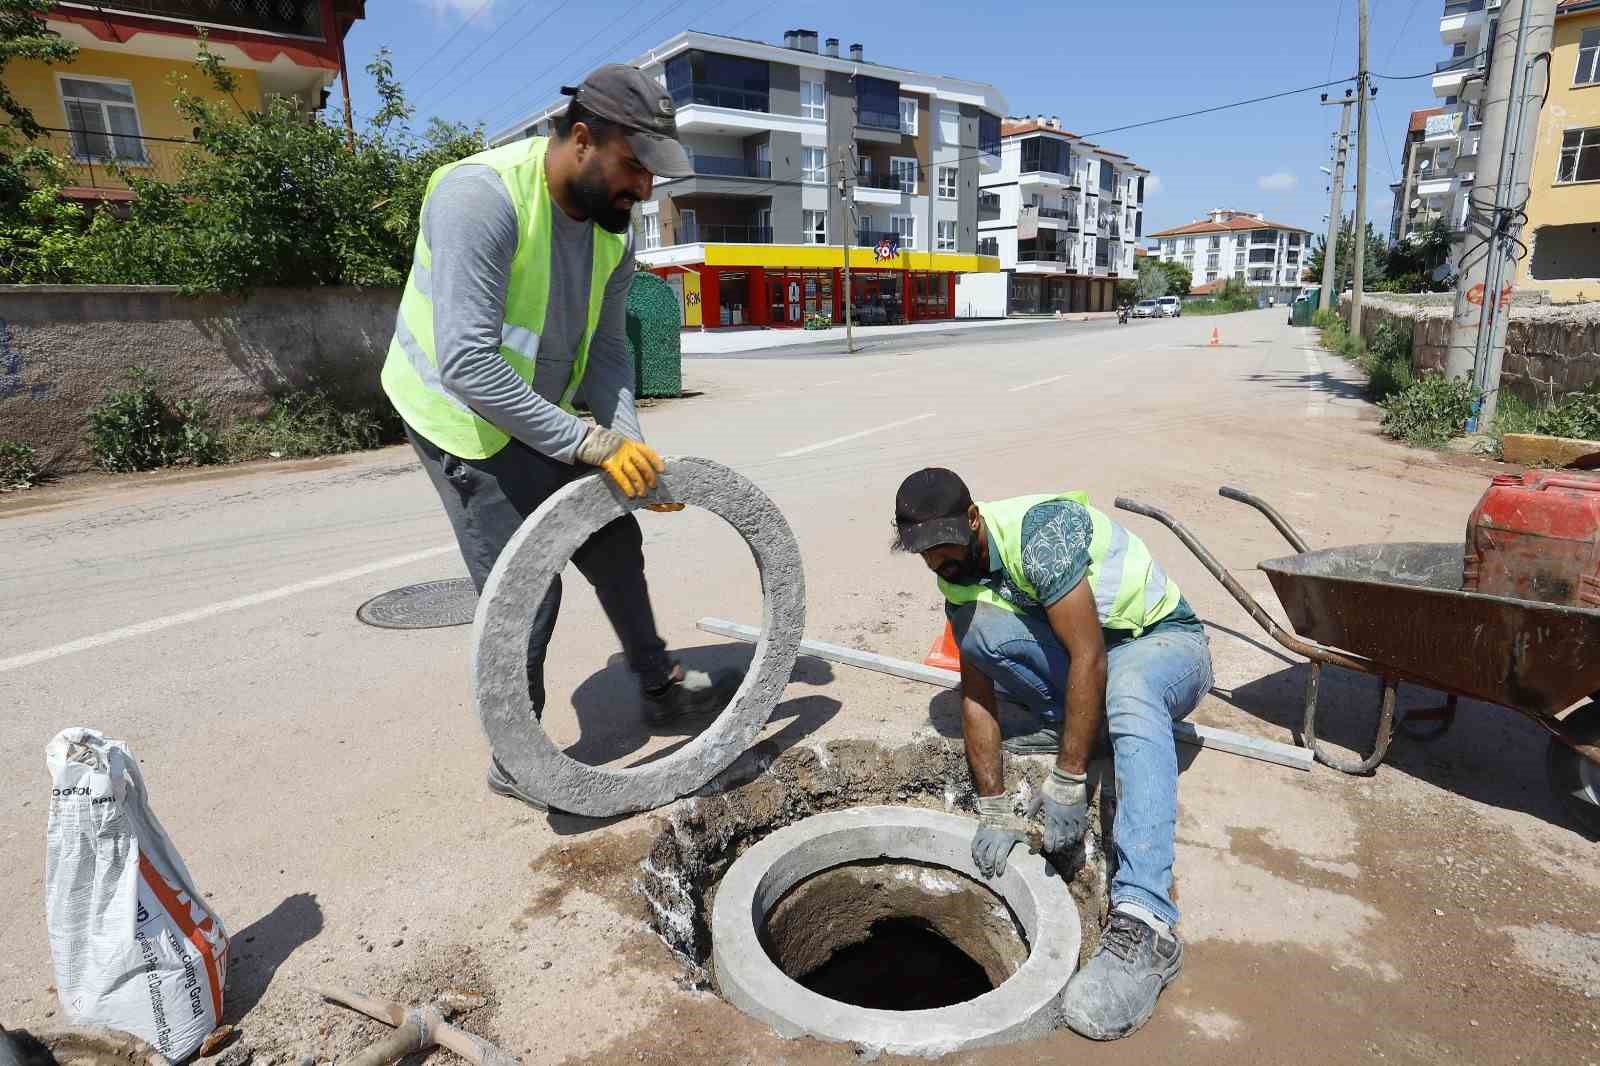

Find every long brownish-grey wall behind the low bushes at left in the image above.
[0,285,400,474]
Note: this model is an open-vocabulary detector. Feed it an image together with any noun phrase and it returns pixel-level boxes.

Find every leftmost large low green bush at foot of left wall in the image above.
[90,367,222,474]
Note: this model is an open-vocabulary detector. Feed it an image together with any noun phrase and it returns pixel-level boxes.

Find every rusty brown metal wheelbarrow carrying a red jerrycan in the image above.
[1117,488,1600,836]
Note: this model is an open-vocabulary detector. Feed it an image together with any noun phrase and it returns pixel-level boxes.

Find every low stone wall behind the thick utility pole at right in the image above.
[1339,293,1600,400]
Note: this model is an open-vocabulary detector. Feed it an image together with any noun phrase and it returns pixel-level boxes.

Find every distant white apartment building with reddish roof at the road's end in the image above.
[1150,208,1310,303]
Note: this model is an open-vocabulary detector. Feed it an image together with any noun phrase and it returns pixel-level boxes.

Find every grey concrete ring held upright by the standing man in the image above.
[472,458,805,818]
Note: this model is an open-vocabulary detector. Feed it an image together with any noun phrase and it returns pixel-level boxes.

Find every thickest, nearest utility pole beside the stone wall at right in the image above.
[1445,0,1555,429]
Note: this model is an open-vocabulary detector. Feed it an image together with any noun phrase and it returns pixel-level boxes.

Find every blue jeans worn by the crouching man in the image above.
[952,603,1211,925]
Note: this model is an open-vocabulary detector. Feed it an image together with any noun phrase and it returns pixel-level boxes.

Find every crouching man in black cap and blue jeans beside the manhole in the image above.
[894,467,1211,1040]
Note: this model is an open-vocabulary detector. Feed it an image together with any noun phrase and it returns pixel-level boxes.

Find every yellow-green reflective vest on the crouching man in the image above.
[938,493,1182,637]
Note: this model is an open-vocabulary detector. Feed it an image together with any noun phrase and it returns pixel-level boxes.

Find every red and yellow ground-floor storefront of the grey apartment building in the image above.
[640,245,998,330]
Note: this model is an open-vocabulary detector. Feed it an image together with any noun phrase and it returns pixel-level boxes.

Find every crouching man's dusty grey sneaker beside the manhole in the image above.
[1061,911,1184,1040]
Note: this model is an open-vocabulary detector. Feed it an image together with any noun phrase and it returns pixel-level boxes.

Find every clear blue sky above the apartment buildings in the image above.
[344,0,1446,232]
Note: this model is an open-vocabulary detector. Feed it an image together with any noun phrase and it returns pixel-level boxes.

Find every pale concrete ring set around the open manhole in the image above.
[710,807,1083,1056]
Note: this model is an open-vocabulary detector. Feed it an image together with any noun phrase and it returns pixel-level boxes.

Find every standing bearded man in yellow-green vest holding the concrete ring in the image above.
[382,64,738,810]
